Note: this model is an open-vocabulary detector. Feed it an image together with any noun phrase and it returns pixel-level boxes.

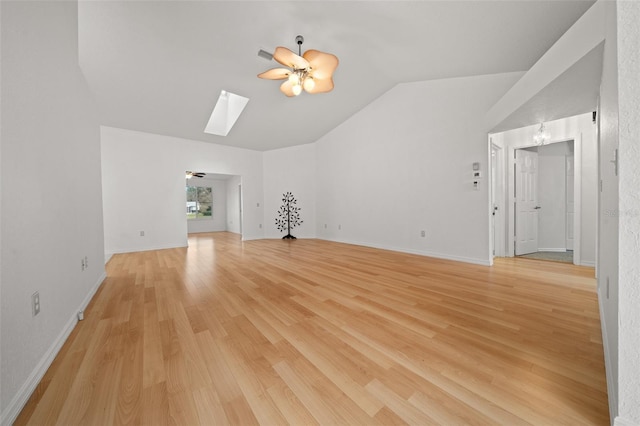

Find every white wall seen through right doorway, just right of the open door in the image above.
[537,142,572,251]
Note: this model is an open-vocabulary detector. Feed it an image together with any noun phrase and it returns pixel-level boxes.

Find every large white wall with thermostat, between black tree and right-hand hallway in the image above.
[316,73,522,264]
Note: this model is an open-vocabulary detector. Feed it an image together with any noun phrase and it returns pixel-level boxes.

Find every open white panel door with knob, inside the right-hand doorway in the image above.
[515,149,540,256]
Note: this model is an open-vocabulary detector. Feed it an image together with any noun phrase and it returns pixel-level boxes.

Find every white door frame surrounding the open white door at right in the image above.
[505,132,582,265]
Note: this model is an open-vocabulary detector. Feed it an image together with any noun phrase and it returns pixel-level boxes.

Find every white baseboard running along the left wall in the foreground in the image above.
[0,272,107,426]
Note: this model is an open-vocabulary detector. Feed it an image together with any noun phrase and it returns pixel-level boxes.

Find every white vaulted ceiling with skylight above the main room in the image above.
[79,0,599,151]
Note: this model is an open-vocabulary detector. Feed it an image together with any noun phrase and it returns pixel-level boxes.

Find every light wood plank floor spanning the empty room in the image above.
[16,233,609,425]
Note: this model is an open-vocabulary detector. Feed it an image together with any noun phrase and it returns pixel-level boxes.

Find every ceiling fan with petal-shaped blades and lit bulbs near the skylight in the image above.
[258,35,338,97]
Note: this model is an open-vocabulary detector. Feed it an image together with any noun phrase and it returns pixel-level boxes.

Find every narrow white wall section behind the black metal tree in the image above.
[264,144,317,238]
